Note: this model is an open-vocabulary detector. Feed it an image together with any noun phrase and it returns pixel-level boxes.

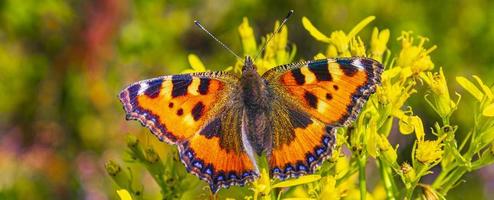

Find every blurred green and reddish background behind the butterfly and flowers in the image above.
[0,0,494,199]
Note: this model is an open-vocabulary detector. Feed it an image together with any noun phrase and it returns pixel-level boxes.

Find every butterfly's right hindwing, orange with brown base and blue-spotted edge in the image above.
[268,103,336,180]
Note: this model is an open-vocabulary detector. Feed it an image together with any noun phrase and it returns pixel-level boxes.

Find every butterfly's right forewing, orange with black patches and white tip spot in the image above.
[263,58,382,126]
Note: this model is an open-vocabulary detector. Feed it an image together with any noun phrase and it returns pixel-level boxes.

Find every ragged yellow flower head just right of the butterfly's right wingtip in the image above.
[396,32,437,74]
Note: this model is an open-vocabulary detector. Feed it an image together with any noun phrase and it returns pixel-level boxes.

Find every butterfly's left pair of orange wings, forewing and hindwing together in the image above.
[119,72,258,192]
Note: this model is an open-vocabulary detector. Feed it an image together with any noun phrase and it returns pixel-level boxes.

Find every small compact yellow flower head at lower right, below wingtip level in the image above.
[415,139,444,164]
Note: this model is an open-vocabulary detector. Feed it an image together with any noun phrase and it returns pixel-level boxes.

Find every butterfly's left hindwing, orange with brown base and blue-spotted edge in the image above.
[179,102,259,192]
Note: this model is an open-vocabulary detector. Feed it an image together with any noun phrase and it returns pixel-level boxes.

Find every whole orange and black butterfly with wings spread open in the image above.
[119,56,383,193]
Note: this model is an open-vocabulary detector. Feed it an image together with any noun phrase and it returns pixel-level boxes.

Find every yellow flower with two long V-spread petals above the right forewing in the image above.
[302,16,376,57]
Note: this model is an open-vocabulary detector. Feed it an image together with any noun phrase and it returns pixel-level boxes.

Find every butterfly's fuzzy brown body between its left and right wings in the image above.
[240,56,271,154]
